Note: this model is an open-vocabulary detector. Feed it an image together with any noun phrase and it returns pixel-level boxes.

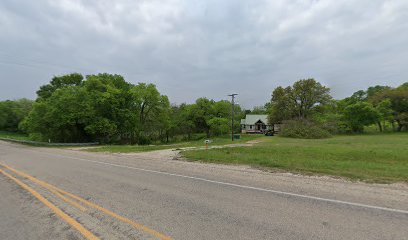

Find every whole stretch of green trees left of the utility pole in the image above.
[0,73,241,144]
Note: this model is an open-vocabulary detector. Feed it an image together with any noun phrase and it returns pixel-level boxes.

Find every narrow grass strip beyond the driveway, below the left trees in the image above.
[86,135,262,153]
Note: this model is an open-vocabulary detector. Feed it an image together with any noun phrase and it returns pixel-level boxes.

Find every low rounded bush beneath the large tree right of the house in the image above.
[279,120,331,139]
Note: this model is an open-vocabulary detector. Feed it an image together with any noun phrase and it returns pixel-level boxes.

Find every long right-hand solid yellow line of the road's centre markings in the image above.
[0,163,172,240]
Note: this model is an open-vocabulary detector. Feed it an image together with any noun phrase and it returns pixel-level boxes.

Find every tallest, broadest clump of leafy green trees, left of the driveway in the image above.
[21,73,170,144]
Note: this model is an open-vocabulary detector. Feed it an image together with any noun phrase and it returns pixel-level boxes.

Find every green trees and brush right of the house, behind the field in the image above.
[264,79,408,137]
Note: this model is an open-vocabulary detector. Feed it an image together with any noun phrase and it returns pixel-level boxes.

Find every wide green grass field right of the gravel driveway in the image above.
[182,133,408,183]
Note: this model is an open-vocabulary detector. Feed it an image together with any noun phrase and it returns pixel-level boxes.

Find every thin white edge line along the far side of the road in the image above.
[27,153,408,214]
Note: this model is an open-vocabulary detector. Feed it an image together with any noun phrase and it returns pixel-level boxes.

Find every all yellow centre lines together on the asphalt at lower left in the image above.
[0,163,172,240]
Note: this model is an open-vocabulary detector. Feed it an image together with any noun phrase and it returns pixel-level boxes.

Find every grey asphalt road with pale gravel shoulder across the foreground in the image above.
[0,141,408,240]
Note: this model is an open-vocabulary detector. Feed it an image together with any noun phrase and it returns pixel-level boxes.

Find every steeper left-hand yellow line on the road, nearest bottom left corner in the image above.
[0,169,99,240]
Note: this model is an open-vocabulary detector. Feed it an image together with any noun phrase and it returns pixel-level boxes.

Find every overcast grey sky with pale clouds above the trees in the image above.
[0,0,408,108]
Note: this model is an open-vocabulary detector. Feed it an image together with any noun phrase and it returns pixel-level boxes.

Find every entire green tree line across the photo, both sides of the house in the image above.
[0,73,408,144]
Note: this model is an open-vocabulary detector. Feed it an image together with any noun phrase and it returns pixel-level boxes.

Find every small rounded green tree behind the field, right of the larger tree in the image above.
[344,102,380,132]
